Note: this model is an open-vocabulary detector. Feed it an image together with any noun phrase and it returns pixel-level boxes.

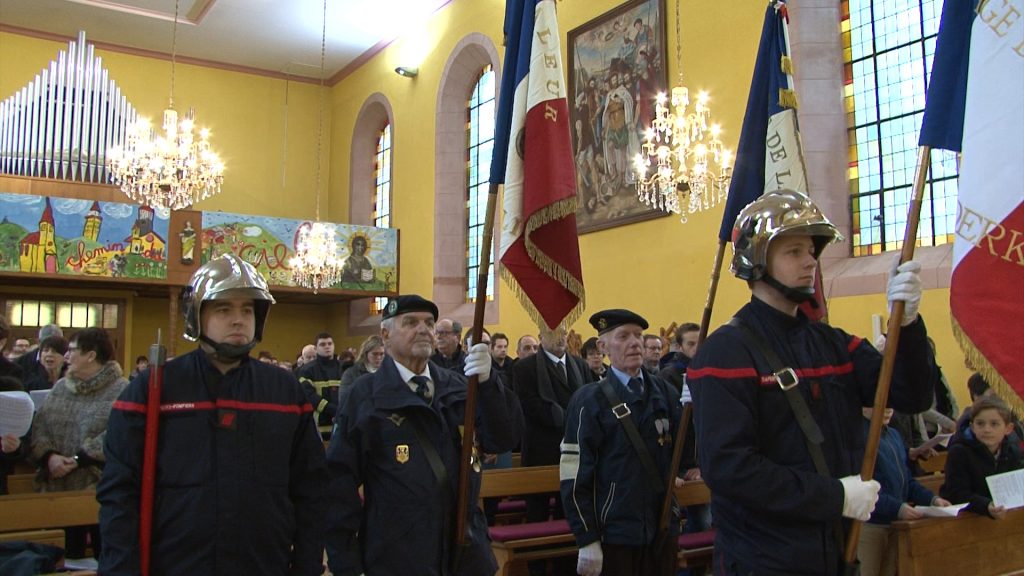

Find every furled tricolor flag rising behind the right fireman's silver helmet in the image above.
[718,0,825,320]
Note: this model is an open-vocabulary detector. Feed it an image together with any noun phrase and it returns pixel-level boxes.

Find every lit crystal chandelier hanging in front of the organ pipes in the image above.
[106,2,224,210]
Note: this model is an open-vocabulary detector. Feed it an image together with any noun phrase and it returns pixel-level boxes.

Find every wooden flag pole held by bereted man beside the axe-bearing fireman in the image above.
[455,182,499,566]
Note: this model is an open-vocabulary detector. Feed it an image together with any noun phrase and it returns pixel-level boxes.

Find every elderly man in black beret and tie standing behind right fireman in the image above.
[559,310,681,576]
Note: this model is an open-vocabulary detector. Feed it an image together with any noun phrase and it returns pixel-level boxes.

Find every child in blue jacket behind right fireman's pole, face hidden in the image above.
[857,407,949,576]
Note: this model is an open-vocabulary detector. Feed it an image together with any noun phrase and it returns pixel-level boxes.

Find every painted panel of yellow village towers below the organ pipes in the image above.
[0,193,170,280]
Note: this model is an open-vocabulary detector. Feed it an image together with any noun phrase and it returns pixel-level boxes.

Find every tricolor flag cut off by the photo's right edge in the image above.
[920,0,1024,409]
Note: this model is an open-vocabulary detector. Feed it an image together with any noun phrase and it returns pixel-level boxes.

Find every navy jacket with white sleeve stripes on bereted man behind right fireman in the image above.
[559,370,681,547]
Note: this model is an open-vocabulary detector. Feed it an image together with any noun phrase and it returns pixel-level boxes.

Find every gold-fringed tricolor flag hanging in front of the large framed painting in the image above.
[490,0,584,328]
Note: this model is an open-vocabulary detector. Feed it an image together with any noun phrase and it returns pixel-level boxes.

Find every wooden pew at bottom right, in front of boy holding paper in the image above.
[893,508,1024,576]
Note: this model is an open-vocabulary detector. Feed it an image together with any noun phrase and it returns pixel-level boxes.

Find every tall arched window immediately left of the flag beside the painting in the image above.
[466,66,496,301]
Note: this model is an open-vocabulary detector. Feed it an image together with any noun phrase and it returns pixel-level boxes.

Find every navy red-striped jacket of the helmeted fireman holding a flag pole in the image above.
[686,298,935,575]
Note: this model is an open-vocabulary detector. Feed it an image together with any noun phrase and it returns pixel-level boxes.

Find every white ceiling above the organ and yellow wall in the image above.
[0,0,451,79]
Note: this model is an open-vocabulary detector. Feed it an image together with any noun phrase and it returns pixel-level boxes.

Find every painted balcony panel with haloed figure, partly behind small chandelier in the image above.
[202,212,398,292]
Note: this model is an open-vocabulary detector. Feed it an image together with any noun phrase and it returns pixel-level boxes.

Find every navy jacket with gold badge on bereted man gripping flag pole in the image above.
[327,356,522,576]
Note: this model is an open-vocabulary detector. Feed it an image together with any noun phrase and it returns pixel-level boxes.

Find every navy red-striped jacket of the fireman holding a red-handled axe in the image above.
[96,351,327,576]
